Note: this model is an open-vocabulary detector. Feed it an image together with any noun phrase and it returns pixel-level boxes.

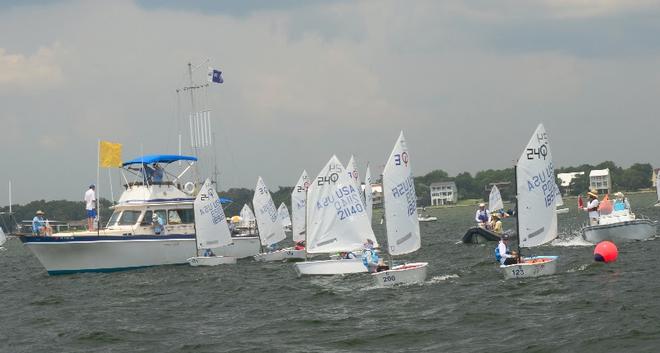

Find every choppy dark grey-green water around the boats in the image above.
[0,194,660,353]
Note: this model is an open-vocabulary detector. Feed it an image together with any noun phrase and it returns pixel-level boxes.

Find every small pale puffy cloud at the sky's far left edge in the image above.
[0,43,64,91]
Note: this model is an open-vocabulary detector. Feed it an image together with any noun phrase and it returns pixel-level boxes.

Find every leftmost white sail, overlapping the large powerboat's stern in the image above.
[193,179,232,249]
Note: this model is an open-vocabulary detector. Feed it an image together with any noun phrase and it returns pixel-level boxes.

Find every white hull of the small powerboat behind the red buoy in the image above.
[582,219,657,244]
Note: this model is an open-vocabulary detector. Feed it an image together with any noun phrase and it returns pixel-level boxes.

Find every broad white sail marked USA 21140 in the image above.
[306,156,378,253]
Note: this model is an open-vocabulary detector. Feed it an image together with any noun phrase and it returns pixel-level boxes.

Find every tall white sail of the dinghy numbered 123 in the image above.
[516,124,557,247]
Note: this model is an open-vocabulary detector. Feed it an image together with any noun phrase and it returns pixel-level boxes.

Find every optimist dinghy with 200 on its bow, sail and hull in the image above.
[371,131,428,286]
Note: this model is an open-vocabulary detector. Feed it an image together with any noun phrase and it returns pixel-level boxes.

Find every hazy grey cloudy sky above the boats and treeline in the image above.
[0,0,660,205]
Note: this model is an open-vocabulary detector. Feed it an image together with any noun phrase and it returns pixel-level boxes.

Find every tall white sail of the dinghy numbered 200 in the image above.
[383,131,421,255]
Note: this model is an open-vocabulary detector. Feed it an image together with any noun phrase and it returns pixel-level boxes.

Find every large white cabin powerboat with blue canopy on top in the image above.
[20,155,259,275]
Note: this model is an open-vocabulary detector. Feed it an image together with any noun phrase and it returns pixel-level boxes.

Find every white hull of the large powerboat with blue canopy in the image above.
[21,234,196,275]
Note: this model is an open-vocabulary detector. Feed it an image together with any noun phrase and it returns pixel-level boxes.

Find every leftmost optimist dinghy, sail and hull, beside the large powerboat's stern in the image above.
[187,179,236,266]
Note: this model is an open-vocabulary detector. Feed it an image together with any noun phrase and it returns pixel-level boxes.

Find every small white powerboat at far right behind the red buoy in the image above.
[582,209,657,244]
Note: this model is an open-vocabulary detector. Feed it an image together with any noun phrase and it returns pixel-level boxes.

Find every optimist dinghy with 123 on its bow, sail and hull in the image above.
[500,124,559,279]
